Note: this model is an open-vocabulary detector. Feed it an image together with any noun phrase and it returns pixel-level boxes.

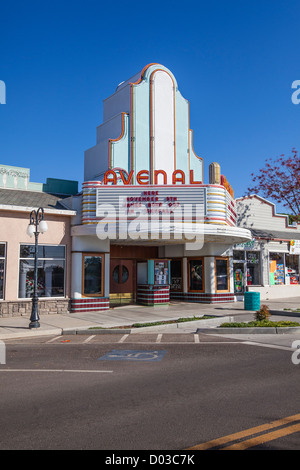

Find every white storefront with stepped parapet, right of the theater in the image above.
[231,195,300,299]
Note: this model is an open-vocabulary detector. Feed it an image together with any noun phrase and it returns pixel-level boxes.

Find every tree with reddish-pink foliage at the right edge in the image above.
[248,148,300,221]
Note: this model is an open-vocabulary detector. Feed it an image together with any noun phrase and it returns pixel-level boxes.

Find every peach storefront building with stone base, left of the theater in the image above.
[0,165,78,316]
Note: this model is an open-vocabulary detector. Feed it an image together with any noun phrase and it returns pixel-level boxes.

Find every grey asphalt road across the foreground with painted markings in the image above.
[0,334,300,452]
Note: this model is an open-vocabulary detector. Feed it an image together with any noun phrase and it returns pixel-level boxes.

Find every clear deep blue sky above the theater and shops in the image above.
[0,0,300,203]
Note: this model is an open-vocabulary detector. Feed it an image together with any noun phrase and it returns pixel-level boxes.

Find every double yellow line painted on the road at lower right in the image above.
[187,414,300,450]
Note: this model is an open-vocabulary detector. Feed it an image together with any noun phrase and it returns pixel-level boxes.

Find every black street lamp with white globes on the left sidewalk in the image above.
[27,207,48,328]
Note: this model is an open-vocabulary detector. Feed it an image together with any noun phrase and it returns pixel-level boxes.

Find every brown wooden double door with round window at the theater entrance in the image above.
[109,258,136,305]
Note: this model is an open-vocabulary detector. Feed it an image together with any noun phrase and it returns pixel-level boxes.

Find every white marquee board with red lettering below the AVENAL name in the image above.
[82,181,236,229]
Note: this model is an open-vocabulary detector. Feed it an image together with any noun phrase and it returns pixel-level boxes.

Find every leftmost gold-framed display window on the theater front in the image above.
[82,254,103,297]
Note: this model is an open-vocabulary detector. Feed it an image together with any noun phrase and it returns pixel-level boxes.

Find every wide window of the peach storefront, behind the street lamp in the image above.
[19,245,65,298]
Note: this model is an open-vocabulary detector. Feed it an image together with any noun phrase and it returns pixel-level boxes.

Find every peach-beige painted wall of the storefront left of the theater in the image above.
[0,210,71,301]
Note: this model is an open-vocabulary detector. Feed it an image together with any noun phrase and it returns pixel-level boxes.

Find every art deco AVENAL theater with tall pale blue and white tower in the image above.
[71,64,251,312]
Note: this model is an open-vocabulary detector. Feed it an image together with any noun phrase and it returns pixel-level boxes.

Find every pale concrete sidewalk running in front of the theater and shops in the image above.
[0,298,300,340]
